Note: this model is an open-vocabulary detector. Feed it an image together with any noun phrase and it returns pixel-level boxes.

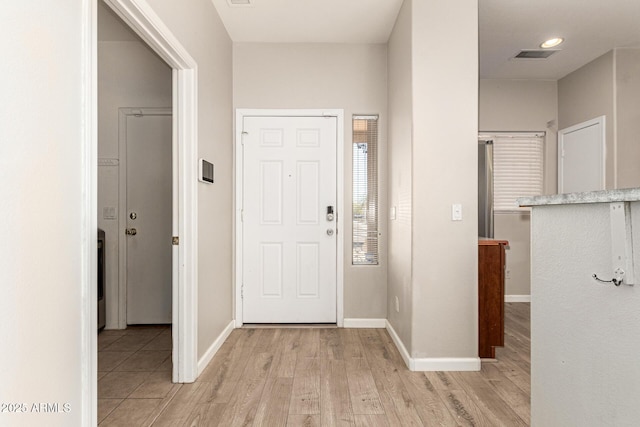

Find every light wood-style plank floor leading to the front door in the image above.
[98,303,531,427]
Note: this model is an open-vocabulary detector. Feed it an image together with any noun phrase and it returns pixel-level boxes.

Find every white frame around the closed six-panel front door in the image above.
[233,109,346,328]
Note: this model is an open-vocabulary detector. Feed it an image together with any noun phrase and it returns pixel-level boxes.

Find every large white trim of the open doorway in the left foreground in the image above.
[102,0,198,383]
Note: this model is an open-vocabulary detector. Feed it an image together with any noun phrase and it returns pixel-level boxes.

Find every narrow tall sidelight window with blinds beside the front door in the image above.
[352,115,378,265]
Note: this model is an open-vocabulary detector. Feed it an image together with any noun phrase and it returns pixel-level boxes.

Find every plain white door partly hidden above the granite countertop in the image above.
[558,117,605,193]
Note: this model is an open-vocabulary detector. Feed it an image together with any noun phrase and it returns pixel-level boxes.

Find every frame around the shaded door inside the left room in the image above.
[118,107,176,329]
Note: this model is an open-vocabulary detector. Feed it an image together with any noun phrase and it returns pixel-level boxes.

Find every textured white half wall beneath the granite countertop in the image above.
[531,198,640,427]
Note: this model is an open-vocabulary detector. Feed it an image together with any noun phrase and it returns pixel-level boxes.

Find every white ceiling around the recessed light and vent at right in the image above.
[479,0,640,80]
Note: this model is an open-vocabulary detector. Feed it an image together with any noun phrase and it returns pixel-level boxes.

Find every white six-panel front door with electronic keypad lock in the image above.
[242,116,337,323]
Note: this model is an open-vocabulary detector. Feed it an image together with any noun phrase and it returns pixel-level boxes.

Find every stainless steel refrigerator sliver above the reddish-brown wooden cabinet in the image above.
[478,139,493,239]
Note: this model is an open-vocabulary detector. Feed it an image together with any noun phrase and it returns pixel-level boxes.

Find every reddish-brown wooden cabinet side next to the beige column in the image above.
[478,240,509,358]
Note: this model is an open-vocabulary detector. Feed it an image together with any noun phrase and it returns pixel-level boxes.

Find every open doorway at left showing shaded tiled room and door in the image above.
[97,5,173,412]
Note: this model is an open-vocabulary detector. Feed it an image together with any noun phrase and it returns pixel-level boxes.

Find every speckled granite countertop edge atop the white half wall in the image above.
[518,188,640,207]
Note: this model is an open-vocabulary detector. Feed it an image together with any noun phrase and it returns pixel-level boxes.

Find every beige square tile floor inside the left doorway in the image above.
[98,325,175,426]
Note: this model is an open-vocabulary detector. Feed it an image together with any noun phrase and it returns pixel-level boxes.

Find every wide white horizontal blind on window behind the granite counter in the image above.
[491,133,544,212]
